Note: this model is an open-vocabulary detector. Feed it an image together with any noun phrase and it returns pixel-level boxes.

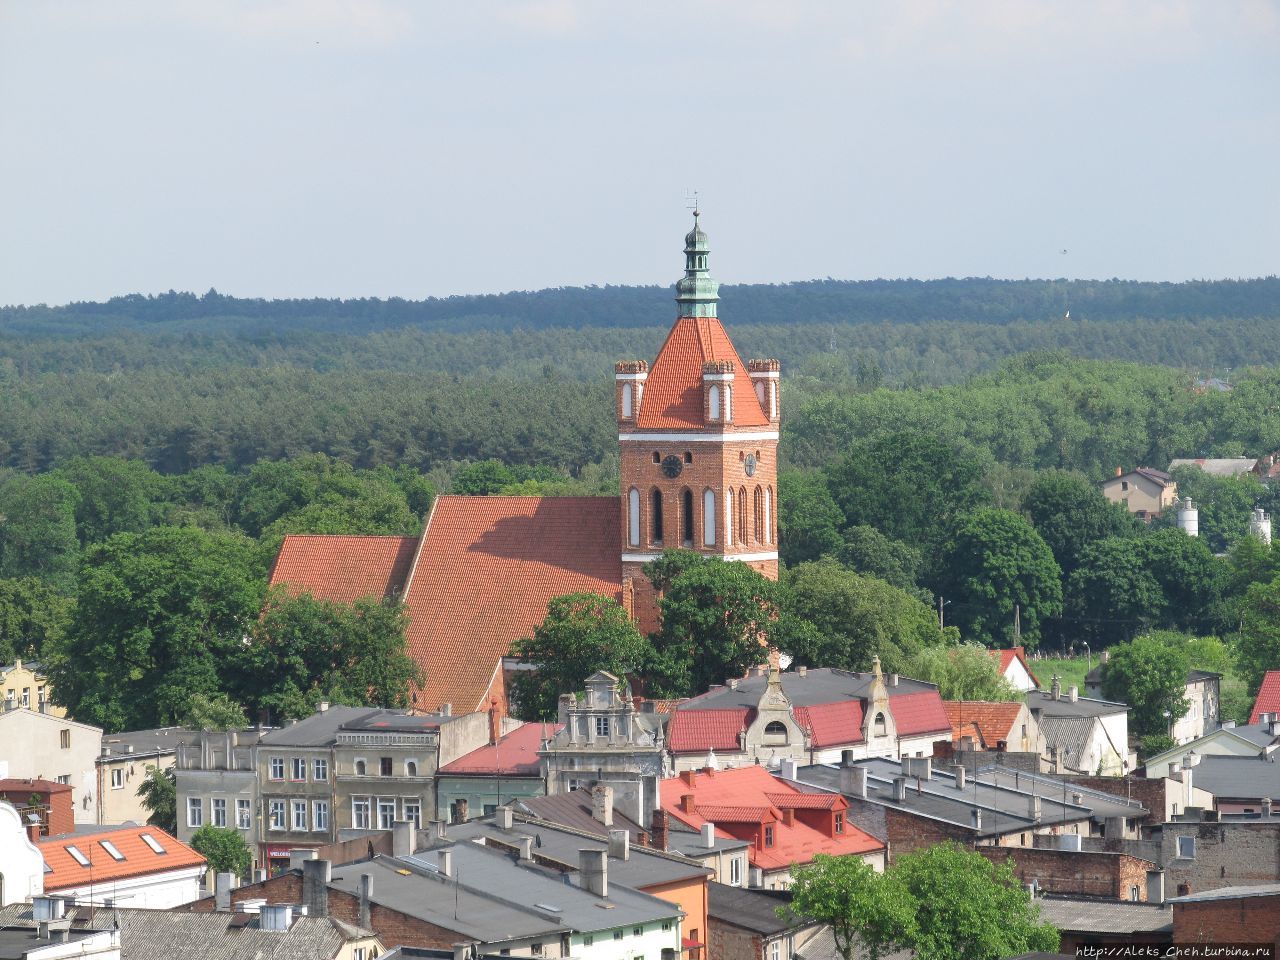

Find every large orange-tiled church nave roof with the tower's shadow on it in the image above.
[404,497,622,712]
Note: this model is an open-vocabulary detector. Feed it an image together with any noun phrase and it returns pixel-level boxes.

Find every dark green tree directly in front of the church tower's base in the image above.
[644,554,778,696]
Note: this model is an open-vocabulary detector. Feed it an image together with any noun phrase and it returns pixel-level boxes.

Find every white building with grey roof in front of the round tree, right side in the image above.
[1027,677,1137,777]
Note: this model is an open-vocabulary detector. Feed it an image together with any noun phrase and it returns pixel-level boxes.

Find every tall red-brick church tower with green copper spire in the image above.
[614,210,778,630]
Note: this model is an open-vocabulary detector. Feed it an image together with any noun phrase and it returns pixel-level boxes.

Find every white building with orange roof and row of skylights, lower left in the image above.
[38,826,207,910]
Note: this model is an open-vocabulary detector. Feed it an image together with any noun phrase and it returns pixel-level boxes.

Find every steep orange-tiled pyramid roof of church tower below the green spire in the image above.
[636,316,769,430]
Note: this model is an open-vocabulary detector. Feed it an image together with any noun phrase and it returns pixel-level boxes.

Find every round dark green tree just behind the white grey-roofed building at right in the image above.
[1102,635,1190,737]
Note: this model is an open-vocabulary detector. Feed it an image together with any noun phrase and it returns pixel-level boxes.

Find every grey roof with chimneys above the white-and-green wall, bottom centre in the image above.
[397,842,684,940]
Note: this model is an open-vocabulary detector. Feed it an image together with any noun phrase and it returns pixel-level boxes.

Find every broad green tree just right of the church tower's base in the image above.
[782,558,942,672]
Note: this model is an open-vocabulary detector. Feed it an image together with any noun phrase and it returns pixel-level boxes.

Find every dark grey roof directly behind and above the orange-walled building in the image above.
[445,814,710,887]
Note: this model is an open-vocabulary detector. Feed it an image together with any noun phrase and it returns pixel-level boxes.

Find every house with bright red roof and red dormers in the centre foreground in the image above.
[655,765,886,890]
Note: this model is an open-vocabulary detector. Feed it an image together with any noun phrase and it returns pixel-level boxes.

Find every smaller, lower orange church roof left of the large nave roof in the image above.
[270,534,417,603]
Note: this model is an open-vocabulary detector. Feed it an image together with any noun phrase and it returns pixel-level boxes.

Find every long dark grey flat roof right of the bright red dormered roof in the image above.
[796,758,1100,837]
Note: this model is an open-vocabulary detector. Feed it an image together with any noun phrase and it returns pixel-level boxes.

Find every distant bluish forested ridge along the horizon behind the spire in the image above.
[0,276,1280,337]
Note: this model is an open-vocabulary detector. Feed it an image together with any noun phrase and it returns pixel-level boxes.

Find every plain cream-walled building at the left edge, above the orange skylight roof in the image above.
[0,700,102,823]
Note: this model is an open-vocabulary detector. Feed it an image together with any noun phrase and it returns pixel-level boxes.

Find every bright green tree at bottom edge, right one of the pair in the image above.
[888,841,1059,960]
